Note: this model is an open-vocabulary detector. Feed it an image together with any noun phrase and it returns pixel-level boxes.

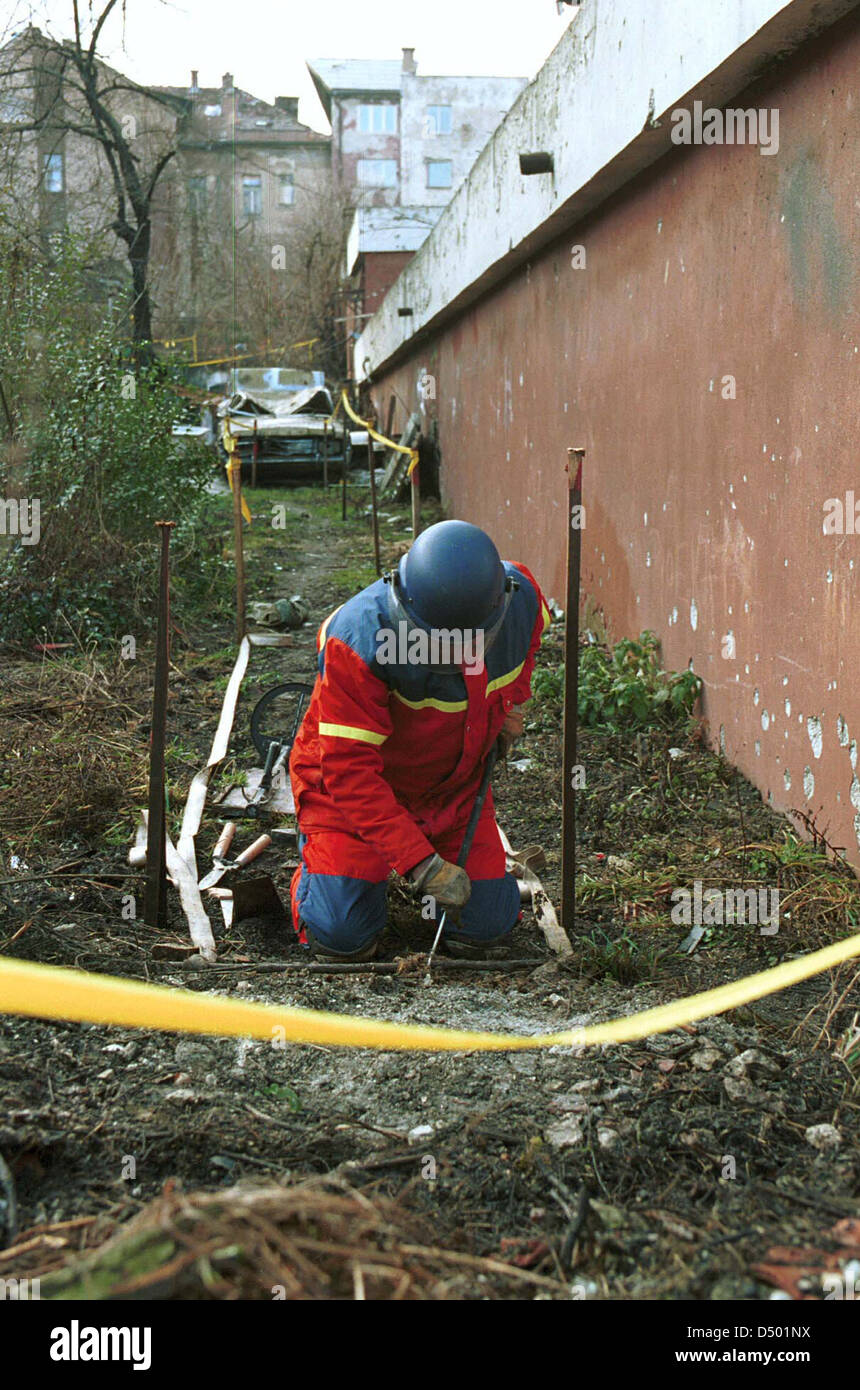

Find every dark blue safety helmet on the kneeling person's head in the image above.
[393,521,514,635]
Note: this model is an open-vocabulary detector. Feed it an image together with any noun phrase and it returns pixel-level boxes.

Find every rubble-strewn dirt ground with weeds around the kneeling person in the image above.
[0,487,860,1300]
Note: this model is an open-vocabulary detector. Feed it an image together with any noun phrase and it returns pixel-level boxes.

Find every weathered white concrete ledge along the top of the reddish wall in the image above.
[356,0,857,377]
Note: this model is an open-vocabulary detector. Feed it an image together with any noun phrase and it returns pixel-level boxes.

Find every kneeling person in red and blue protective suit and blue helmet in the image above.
[290,521,550,960]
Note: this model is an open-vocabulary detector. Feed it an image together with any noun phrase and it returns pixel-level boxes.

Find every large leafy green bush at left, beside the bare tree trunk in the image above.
[0,225,213,642]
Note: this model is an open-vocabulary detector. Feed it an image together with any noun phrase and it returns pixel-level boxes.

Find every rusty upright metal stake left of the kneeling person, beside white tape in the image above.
[143,521,175,929]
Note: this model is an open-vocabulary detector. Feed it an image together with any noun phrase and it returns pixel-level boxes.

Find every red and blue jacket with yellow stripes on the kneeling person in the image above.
[290,563,550,876]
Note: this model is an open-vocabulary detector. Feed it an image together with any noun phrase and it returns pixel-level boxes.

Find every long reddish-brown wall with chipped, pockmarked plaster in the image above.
[356,4,860,863]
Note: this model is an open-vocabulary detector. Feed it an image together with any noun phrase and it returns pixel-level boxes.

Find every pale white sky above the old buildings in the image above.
[8,0,575,131]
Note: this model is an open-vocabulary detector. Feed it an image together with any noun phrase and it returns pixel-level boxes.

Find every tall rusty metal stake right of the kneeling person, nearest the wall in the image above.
[561,449,585,937]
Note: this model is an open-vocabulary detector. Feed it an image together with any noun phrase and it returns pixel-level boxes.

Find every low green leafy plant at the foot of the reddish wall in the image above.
[532,632,702,733]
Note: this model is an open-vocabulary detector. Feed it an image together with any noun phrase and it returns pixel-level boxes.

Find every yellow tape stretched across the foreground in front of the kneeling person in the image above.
[0,934,860,1052]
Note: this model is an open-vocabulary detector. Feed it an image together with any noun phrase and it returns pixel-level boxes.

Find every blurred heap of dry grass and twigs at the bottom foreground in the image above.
[0,1177,565,1302]
